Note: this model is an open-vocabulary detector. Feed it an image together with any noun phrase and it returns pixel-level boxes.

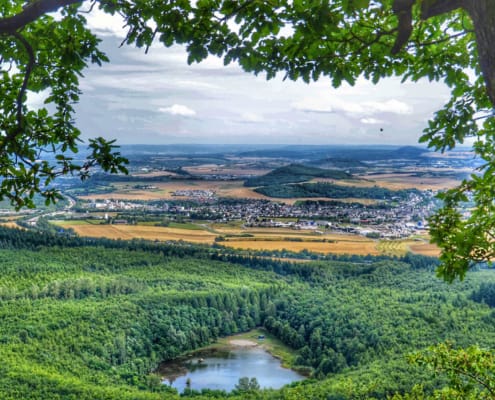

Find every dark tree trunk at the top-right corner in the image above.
[464,0,495,108]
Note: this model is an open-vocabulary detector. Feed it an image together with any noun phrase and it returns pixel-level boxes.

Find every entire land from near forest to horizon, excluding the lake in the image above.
[0,142,488,400]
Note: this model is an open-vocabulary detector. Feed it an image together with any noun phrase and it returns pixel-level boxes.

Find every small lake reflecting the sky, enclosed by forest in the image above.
[158,347,305,393]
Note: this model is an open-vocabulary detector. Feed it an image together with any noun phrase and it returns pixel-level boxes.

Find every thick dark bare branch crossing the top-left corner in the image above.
[0,0,81,34]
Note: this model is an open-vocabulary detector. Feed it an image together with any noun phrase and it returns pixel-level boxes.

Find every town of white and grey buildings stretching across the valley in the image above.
[72,190,435,238]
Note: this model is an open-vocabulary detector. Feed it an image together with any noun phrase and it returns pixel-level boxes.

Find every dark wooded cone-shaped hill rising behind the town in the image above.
[244,164,353,187]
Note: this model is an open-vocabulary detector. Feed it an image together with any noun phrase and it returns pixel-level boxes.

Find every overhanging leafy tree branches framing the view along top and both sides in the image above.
[0,0,495,280]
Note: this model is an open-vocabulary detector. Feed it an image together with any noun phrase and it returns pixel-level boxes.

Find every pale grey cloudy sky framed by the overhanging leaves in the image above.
[70,6,454,144]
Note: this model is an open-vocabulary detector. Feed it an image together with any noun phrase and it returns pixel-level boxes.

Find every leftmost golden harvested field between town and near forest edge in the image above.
[52,221,215,244]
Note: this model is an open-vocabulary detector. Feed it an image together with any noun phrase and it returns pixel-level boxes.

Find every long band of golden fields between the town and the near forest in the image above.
[51,220,438,256]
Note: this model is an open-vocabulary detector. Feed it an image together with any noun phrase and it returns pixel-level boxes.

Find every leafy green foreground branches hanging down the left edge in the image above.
[0,0,127,208]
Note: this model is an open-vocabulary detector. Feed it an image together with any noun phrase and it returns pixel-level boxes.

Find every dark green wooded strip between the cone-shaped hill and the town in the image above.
[255,182,419,200]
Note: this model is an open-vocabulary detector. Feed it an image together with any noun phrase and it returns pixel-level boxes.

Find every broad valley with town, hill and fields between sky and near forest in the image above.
[16,146,477,257]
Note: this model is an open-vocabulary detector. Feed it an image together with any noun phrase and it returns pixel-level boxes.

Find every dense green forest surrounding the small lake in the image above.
[0,228,495,400]
